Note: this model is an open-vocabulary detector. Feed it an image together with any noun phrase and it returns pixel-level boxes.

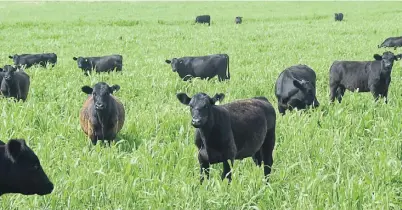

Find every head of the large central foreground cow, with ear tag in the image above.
[176,93,225,128]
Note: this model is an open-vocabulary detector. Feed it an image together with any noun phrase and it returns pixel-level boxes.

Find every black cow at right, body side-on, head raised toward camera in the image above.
[329,51,402,103]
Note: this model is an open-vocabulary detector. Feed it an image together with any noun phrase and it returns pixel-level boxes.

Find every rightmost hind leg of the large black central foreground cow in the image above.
[261,128,275,182]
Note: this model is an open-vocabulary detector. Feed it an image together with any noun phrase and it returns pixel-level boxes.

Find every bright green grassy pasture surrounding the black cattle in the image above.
[0,2,402,210]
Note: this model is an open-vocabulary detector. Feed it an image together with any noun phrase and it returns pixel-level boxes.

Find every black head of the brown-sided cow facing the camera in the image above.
[81,82,120,113]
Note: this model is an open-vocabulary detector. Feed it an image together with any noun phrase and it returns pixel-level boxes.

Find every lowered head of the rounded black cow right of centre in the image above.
[290,79,315,106]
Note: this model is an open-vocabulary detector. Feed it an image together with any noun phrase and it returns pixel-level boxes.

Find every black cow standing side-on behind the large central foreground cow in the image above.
[165,54,230,81]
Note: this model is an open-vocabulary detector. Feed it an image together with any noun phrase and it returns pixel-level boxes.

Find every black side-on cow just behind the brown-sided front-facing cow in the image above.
[73,55,123,76]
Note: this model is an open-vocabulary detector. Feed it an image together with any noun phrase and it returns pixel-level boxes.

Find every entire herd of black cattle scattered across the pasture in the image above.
[0,13,402,198]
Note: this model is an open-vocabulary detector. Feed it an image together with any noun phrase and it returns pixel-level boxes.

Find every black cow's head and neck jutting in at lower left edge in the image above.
[0,139,53,196]
